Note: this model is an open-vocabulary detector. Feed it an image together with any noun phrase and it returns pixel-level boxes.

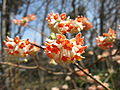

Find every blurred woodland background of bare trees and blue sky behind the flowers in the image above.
[0,0,120,90]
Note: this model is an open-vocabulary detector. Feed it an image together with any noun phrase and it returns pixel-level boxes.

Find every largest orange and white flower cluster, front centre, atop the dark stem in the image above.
[45,33,87,65]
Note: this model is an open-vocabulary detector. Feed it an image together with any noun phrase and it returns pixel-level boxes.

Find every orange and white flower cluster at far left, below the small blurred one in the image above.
[4,37,39,57]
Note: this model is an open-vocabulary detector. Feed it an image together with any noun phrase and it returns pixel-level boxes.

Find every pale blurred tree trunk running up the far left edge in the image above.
[0,0,7,89]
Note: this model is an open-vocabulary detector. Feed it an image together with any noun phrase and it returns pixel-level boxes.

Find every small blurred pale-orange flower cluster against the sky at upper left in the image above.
[13,14,36,26]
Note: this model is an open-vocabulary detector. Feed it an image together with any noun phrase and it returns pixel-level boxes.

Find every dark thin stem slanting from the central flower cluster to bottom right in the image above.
[74,63,110,90]
